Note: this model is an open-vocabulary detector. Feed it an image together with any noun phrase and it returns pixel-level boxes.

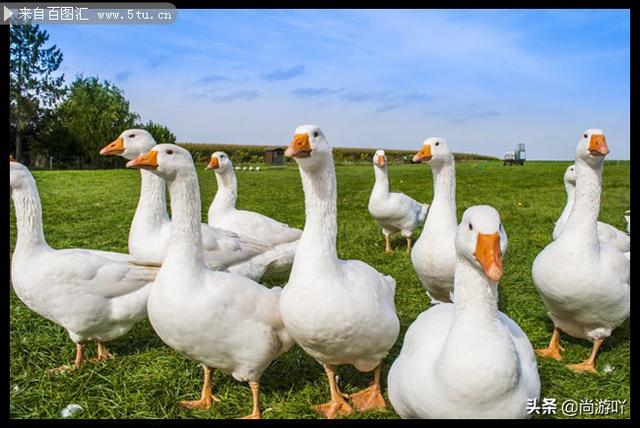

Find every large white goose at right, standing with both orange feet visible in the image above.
[532,129,630,372]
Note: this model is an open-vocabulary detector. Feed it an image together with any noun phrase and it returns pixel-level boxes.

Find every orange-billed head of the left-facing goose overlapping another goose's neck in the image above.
[127,144,194,181]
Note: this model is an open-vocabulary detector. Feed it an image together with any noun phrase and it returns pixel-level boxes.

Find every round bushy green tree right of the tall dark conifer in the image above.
[53,75,139,165]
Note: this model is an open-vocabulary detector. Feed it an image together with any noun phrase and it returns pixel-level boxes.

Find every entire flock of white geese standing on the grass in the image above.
[10,125,630,419]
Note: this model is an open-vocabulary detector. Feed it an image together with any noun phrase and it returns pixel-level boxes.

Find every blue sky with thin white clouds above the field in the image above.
[45,10,630,159]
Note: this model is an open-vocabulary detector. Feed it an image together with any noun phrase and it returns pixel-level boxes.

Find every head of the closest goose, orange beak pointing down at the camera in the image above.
[456,205,507,284]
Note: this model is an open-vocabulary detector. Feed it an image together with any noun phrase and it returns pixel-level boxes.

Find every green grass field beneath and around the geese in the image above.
[9,161,630,418]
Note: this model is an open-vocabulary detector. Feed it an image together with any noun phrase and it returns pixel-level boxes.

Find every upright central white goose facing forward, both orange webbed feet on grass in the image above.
[280,125,400,418]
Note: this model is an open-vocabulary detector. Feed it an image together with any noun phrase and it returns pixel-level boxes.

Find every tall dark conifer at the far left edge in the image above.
[9,25,65,162]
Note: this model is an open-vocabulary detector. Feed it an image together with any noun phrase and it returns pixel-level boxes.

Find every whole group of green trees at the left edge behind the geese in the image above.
[9,25,176,167]
